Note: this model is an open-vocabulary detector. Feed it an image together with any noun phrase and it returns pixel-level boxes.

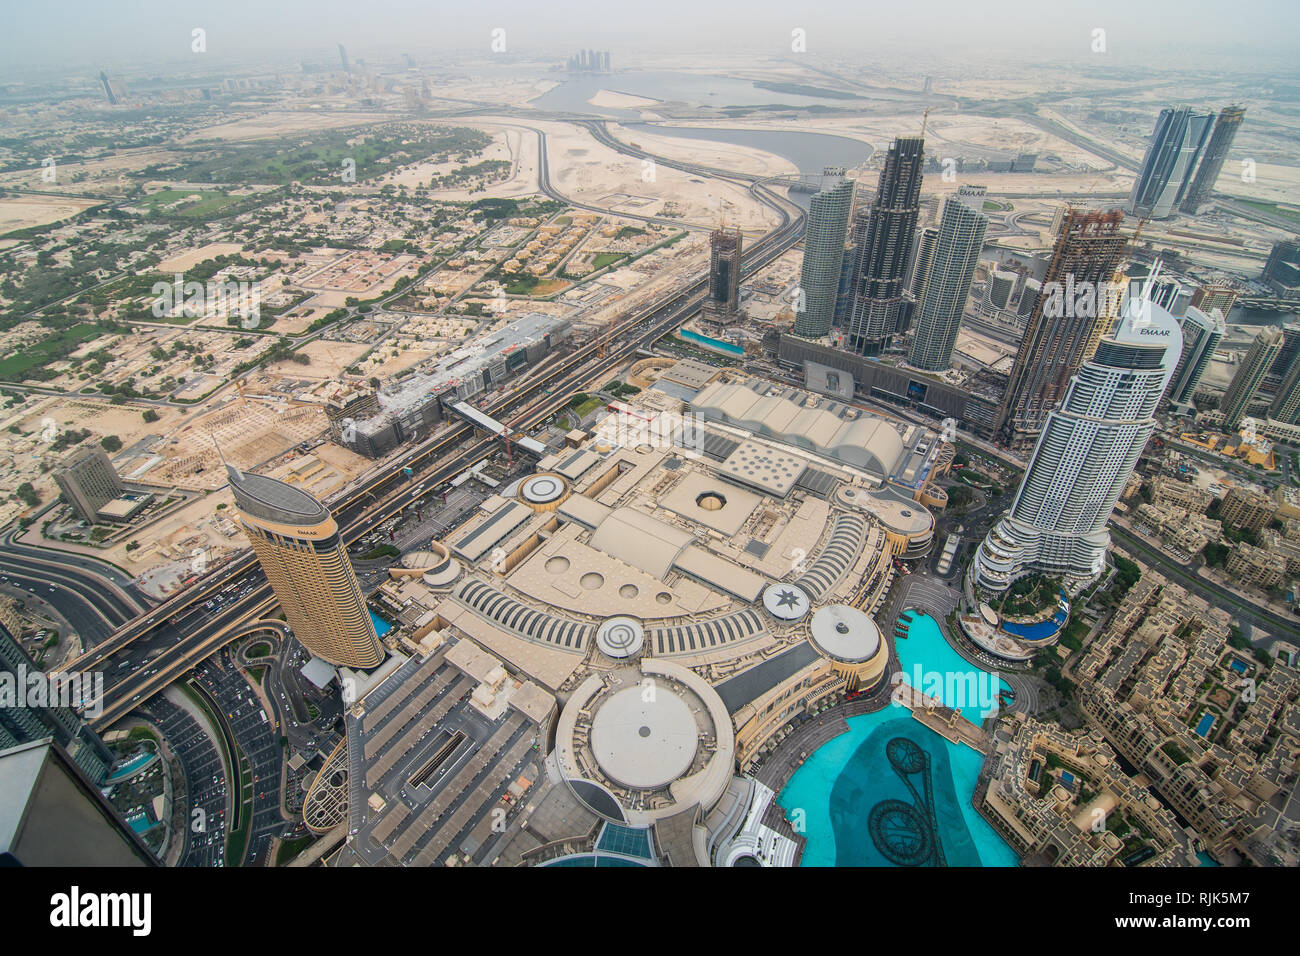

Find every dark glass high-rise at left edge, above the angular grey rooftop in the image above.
[0,623,113,784]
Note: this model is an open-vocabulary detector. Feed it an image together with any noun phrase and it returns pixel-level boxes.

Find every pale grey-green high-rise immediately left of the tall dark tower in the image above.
[792,166,853,338]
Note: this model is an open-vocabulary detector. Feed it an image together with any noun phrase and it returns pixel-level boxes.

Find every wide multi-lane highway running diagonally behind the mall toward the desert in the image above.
[68,124,803,728]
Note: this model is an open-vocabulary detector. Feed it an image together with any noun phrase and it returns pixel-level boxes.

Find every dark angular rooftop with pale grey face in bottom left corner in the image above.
[0,740,159,868]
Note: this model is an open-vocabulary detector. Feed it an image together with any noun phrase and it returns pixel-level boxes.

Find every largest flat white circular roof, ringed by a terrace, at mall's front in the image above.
[590,684,699,790]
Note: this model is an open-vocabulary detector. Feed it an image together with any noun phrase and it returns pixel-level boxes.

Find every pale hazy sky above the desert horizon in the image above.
[0,0,1300,75]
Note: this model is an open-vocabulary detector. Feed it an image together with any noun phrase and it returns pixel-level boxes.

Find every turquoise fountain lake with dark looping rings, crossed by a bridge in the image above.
[777,613,1018,866]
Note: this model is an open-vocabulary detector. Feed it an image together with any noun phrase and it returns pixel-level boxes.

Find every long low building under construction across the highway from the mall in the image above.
[325,312,571,458]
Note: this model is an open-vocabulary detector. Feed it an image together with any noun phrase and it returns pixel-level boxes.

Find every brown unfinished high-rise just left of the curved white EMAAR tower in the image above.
[998,208,1127,445]
